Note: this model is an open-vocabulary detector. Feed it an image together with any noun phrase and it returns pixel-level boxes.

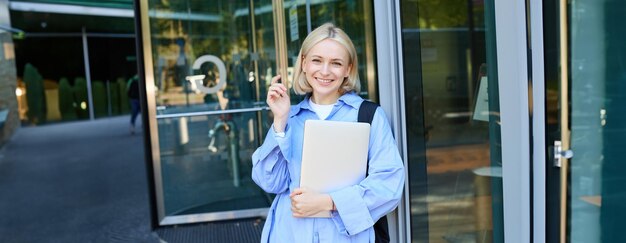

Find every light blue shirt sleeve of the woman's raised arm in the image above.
[252,125,291,194]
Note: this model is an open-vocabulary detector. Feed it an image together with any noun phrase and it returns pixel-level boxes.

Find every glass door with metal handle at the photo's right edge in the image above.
[544,0,626,243]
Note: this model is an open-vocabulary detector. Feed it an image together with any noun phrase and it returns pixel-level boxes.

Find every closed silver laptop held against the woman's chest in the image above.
[300,120,370,218]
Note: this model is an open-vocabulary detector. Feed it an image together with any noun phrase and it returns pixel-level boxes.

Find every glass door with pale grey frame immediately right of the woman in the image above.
[397,0,532,242]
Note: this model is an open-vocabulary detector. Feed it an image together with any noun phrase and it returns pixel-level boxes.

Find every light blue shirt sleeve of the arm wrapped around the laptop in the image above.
[330,107,405,235]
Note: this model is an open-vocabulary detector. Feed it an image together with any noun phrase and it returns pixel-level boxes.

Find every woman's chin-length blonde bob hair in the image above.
[292,23,361,95]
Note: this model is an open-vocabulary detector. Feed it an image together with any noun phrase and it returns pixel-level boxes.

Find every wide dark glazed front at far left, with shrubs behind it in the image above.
[10,10,137,125]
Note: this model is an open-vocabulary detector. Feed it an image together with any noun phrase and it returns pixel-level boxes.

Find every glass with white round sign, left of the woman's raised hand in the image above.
[149,0,275,219]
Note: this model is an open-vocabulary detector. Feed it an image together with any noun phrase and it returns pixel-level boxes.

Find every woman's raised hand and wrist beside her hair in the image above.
[267,75,291,132]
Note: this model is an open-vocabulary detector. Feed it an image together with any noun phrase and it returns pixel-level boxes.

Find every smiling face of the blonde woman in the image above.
[302,39,352,105]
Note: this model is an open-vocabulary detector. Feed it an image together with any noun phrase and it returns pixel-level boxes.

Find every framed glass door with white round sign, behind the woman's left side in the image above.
[139,0,376,225]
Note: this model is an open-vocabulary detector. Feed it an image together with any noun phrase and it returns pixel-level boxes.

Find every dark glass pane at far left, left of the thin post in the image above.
[14,36,89,125]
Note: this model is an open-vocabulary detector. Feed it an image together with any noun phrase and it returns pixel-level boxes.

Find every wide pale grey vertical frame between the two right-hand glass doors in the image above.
[494,0,532,242]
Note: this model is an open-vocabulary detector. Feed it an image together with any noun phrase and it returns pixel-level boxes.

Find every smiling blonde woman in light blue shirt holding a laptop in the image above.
[252,24,404,243]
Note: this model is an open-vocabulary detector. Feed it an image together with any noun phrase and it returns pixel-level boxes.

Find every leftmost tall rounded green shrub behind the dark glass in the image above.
[24,63,46,124]
